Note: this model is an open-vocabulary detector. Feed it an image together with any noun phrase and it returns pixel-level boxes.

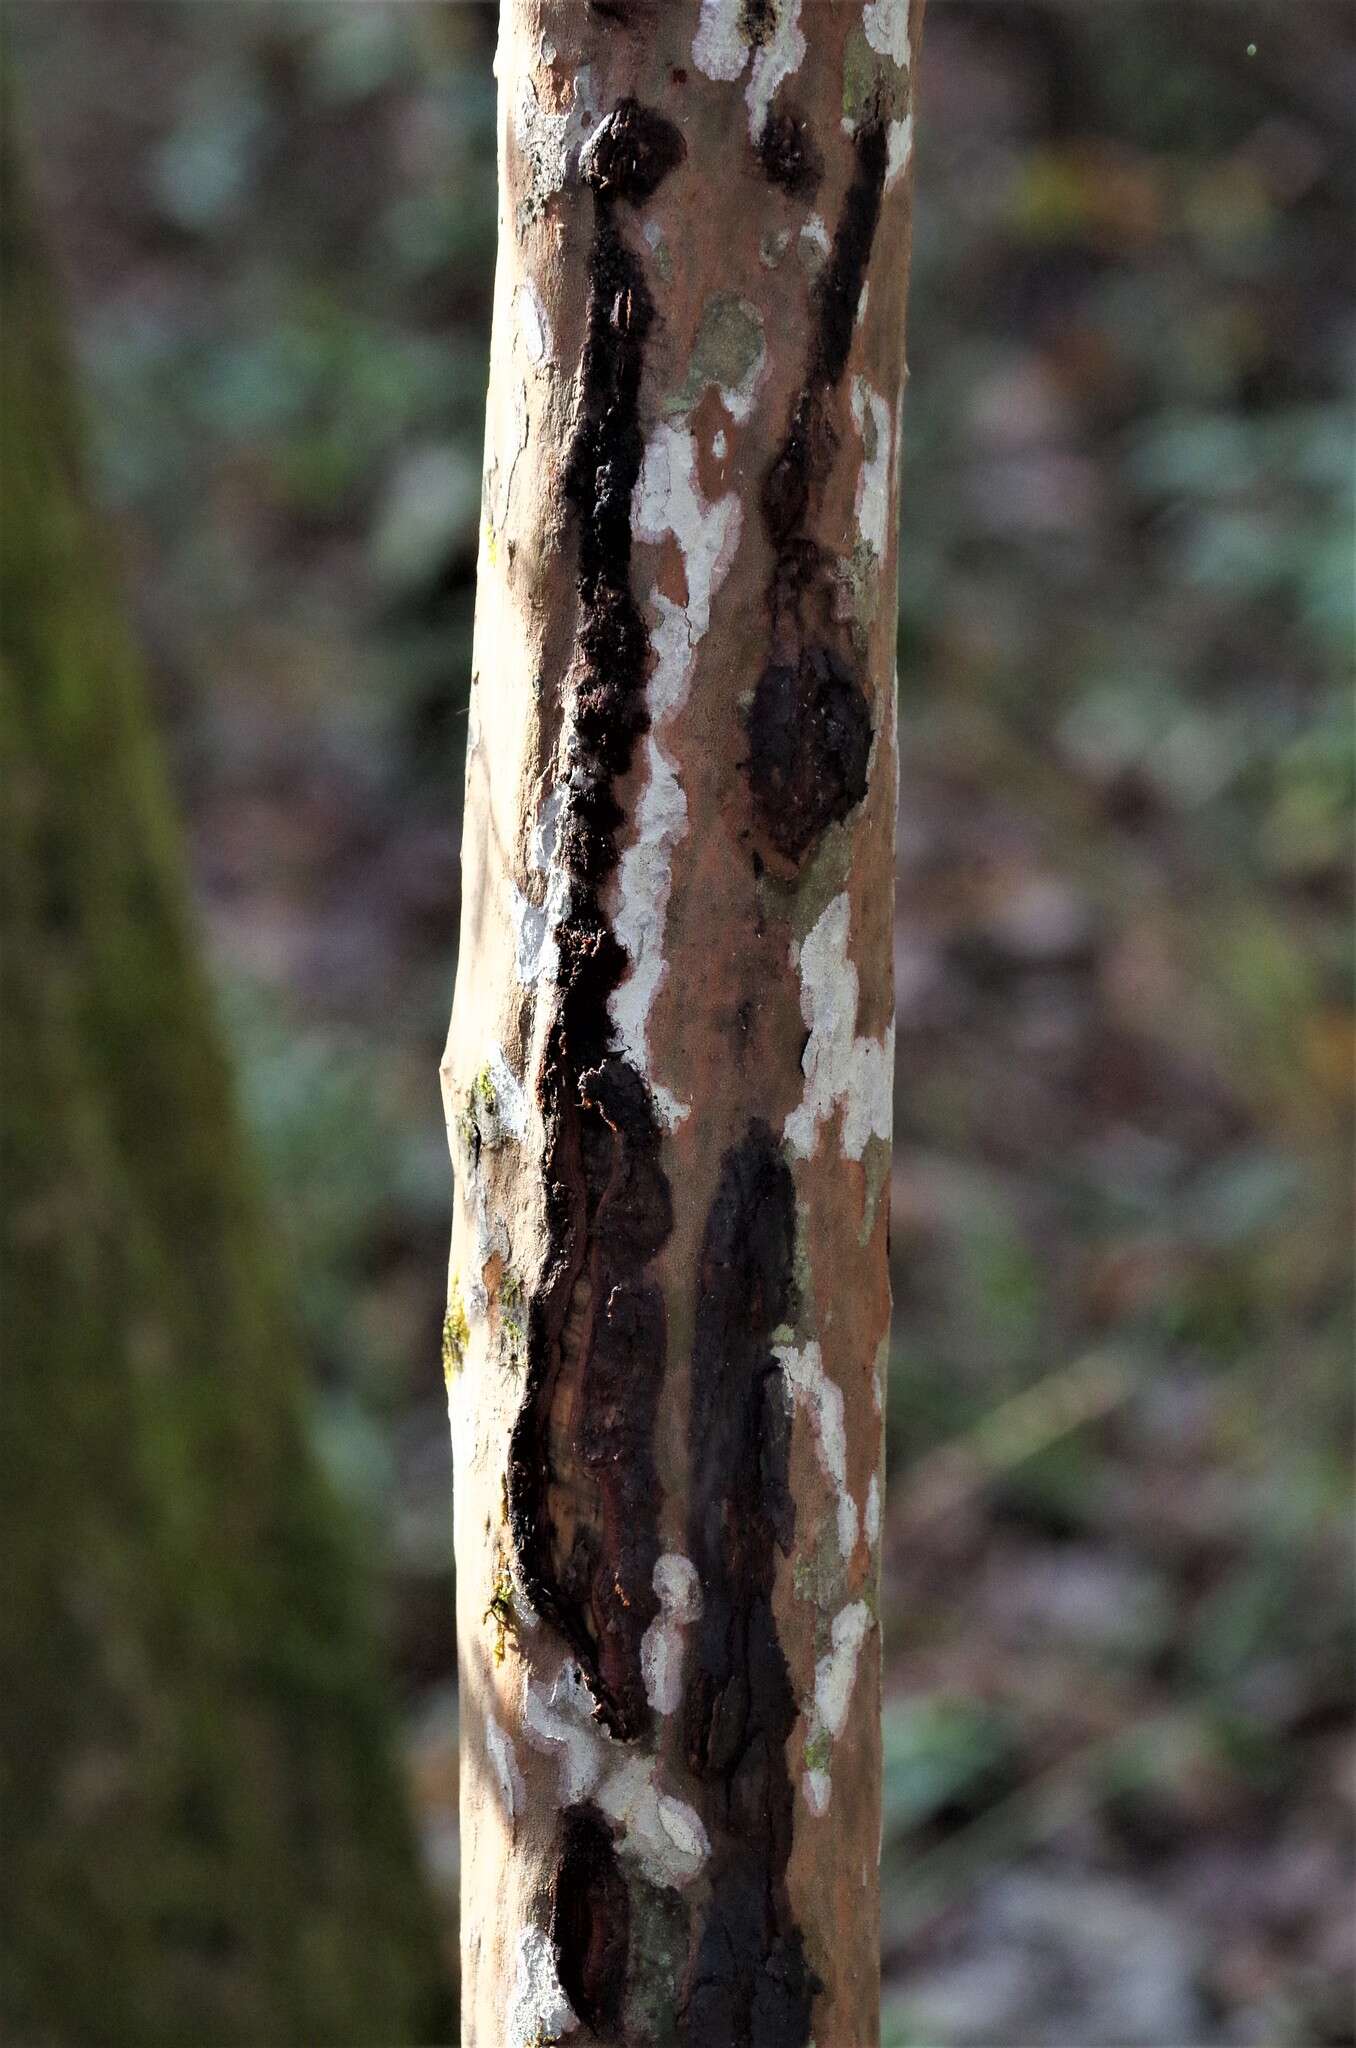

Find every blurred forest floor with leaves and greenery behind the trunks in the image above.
[6,0,1356,2048]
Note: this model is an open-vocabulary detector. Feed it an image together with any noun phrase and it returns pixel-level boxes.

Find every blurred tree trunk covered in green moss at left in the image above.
[0,108,456,2048]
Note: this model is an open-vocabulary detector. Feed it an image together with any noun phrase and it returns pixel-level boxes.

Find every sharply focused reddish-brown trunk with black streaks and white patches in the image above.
[444,0,920,2048]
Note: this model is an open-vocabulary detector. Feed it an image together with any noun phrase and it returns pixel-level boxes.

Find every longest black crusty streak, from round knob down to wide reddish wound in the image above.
[508,100,682,1744]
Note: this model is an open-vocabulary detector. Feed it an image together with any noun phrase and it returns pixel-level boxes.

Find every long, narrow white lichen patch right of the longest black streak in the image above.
[608,422,741,1128]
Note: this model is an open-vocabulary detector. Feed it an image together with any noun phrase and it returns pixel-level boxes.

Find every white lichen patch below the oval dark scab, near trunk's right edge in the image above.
[782,891,895,1159]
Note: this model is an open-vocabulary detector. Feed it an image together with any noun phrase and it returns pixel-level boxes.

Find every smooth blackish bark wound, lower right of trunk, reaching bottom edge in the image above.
[682,1122,819,2048]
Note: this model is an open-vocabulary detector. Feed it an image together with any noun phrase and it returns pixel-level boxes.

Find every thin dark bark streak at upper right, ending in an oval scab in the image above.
[746,117,887,872]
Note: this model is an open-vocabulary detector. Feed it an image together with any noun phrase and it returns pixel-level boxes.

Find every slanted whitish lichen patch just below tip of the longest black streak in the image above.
[522,1659,711,1884]
